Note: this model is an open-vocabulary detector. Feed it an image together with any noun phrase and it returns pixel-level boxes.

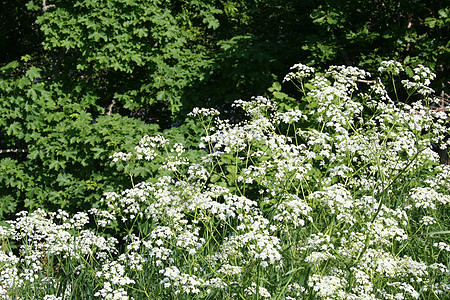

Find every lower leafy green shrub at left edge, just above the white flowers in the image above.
[0,62,157,215]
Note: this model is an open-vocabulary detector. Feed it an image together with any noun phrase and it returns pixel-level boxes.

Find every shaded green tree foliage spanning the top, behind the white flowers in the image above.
[5,0,449,118]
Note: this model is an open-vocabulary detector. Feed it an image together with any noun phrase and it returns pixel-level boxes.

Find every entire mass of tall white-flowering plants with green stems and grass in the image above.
[0,61,450,299]
